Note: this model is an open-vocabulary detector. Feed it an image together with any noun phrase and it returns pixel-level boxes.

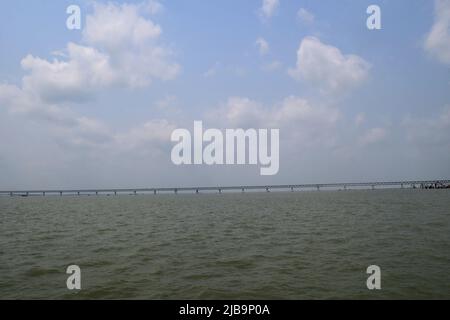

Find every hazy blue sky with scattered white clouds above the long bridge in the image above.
[0,0,450,190]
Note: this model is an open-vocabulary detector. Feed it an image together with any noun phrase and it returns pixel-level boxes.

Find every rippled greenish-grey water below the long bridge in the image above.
[0,190,450,299]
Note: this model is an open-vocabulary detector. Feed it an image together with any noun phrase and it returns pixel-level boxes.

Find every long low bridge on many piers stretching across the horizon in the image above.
[0,180,450,196]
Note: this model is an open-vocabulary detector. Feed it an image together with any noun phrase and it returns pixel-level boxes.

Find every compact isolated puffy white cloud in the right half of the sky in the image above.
[288,37,370,93]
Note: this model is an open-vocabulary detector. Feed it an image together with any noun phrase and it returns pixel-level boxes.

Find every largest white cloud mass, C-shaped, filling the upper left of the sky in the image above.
[0,1,179,152]
